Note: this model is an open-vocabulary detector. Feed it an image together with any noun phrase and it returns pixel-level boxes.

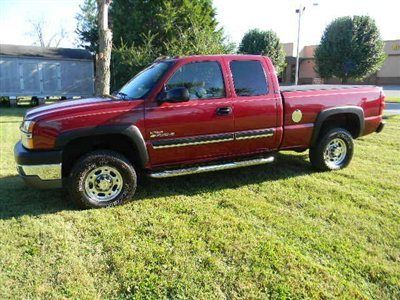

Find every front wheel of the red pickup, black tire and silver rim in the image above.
[68,150,137,208]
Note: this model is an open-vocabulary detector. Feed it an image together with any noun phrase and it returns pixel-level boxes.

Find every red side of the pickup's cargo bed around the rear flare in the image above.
[281,84,382,149]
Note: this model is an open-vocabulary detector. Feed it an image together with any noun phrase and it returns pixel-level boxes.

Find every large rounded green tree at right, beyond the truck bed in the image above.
[315,16,386,83]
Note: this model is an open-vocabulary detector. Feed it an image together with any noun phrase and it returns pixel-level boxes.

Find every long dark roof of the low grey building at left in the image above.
[0,44,92,60]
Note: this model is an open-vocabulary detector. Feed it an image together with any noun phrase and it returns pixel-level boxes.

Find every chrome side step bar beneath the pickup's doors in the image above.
[149,156,275,178]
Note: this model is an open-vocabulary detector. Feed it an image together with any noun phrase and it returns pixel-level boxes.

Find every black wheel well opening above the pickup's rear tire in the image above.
[318,113,361,138]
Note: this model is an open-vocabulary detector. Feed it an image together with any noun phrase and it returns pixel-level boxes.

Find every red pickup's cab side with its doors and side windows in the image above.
[144,56,282,167]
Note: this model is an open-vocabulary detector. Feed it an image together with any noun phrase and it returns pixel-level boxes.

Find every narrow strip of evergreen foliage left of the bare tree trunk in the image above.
[75,0,99,54]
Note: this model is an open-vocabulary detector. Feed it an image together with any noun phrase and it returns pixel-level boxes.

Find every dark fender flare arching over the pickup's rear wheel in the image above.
[311,106,364,147]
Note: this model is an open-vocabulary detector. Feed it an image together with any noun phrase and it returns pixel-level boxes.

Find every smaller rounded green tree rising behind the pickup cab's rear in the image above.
[239,29,286,73]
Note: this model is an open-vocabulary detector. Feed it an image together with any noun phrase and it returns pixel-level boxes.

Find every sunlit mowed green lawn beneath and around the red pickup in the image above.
[0,108,400,299]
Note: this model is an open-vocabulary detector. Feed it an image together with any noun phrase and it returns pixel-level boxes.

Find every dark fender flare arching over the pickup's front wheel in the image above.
[55,125,149,168]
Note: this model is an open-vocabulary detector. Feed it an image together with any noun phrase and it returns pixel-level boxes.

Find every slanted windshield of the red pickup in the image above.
[117,61,173,99]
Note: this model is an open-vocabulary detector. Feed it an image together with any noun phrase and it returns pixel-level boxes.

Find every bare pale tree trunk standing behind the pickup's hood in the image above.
[95,0,112,96]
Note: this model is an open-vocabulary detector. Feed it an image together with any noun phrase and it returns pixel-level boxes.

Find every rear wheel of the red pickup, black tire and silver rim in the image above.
[309,128,354,171]
